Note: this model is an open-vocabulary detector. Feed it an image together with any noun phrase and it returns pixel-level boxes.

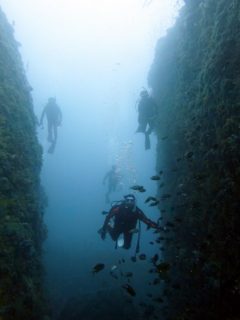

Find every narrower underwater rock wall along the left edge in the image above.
[0,10,46,319]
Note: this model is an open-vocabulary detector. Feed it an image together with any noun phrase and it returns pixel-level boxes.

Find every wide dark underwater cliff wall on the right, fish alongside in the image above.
[149,0,240,319]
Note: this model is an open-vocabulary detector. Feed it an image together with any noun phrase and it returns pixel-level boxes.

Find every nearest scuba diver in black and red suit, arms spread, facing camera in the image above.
[98,194,159,252]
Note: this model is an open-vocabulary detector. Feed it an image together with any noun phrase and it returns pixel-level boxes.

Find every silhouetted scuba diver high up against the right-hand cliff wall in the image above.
[136,89,157,150]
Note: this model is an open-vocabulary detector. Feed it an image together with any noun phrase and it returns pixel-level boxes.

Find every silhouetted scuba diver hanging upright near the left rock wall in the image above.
[40,98,62,153]
